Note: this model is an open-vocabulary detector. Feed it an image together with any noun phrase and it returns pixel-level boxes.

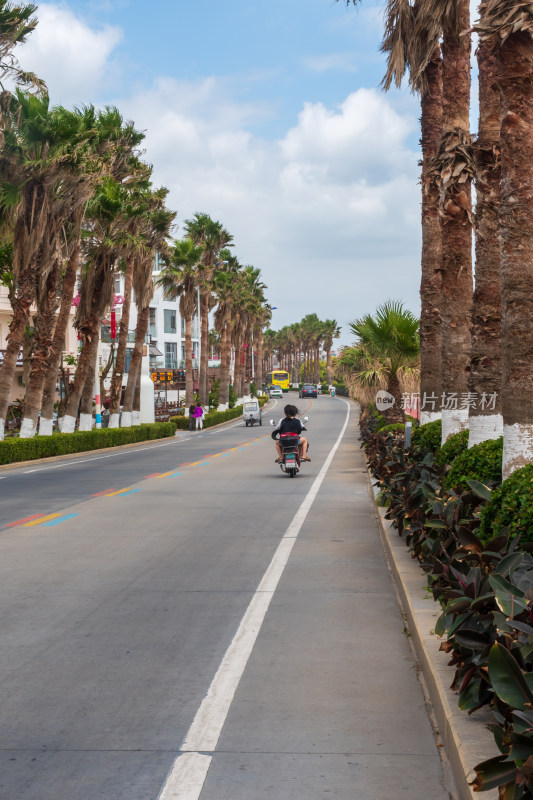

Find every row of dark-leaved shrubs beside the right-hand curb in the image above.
[361,416,533,800]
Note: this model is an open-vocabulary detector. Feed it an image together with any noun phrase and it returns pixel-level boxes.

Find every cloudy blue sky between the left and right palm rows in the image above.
[19,0,419,343]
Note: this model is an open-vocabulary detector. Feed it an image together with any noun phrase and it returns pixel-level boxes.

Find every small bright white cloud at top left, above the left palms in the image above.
[17,3,122,105]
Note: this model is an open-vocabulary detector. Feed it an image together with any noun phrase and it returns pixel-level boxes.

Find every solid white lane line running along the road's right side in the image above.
[159,400,350,800]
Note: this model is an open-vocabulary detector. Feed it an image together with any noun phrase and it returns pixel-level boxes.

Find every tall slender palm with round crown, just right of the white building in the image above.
[185,213,233,405]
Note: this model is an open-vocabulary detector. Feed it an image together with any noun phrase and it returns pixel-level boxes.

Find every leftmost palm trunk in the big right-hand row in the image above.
[418,47,442,425]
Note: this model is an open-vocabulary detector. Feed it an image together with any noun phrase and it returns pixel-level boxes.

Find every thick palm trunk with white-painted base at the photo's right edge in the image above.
[497,32,533,478]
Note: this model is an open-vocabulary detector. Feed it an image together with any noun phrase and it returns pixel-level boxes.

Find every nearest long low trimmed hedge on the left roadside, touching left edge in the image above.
[0,422,176,464]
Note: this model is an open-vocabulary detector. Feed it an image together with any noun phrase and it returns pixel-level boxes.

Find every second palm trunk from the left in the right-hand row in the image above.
[439,0,472,443]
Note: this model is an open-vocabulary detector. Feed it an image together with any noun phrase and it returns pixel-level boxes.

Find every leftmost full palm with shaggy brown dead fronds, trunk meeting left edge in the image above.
[0,90,101,438]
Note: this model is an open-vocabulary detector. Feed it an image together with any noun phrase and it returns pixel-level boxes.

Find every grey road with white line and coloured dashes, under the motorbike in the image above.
[0,397,448,800]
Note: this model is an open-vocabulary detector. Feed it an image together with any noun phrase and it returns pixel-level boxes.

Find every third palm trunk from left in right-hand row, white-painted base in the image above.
[468,40,503,447]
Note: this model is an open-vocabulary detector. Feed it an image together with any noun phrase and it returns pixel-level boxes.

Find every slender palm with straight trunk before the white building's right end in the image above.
[156,234,203,409]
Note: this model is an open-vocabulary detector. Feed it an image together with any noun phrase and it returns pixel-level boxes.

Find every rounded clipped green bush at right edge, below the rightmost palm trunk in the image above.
[479,464,533,544]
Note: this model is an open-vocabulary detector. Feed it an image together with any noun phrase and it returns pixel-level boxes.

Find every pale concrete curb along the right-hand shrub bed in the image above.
[368,474,498,800]
